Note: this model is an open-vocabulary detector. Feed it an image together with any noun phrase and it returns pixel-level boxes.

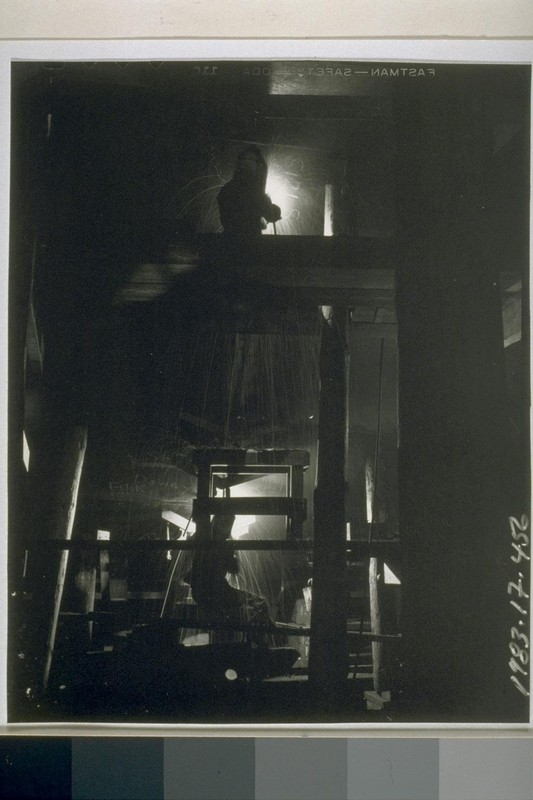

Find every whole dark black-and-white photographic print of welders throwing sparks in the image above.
[7,59,531,728]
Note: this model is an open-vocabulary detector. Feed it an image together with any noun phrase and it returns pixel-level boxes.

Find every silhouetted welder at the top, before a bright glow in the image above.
[217,145,281,239]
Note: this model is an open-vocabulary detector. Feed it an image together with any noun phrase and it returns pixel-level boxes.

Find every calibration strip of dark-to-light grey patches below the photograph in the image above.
[0,732,533,800]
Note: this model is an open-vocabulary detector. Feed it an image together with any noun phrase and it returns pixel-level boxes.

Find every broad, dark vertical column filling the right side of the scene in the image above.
[397,81,524,722]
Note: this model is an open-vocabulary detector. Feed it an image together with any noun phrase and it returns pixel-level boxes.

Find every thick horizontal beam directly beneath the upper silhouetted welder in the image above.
[116,236,395,306]
